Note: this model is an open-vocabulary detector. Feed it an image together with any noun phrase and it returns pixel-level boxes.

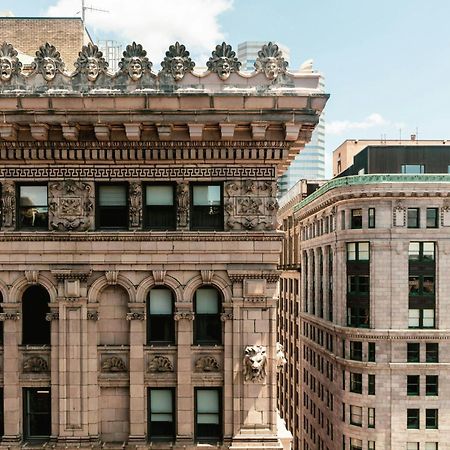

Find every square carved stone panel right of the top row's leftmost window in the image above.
[49,180,94,231]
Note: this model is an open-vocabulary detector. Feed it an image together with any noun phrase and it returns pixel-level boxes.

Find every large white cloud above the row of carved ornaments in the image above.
[47,0,234,66]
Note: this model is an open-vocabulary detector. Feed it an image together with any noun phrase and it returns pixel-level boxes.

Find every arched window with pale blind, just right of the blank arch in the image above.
[147,288,175,344]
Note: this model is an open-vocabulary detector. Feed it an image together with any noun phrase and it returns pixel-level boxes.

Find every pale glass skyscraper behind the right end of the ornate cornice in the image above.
[238,41,325,198]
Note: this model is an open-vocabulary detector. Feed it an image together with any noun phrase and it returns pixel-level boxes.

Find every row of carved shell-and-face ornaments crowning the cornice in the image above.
[0,42,288,82]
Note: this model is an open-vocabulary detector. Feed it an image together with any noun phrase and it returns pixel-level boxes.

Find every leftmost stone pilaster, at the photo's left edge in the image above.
[0,303,22,444]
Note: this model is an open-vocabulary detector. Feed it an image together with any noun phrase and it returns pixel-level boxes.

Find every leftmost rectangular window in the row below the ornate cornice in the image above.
[18,185,48,230]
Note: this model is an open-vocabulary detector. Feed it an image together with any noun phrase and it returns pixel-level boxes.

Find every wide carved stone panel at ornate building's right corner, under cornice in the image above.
[224,179,278,231]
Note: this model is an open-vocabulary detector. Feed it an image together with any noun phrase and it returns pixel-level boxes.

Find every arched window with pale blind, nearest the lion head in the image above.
[194,287,222,345]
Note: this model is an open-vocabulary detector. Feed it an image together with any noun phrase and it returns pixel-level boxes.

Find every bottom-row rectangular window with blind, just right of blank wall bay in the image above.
[148,388,175,441]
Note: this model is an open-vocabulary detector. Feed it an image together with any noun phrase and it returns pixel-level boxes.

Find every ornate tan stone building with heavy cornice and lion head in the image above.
[0,43,328,450]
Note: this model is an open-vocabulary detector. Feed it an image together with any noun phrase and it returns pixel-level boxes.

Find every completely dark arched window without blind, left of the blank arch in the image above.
[22,286,50,345]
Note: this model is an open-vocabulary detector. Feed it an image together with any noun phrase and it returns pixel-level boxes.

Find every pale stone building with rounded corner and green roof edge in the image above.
[278,145,450,450]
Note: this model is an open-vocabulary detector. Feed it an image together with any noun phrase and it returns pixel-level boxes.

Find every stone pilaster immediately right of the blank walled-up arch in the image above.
[127,303,147,444]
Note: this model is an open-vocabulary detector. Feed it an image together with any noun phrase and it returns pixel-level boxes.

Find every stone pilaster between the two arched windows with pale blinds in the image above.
[174,303,194,445]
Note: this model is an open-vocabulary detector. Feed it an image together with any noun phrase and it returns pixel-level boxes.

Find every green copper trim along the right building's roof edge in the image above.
[294,174,450,212]
